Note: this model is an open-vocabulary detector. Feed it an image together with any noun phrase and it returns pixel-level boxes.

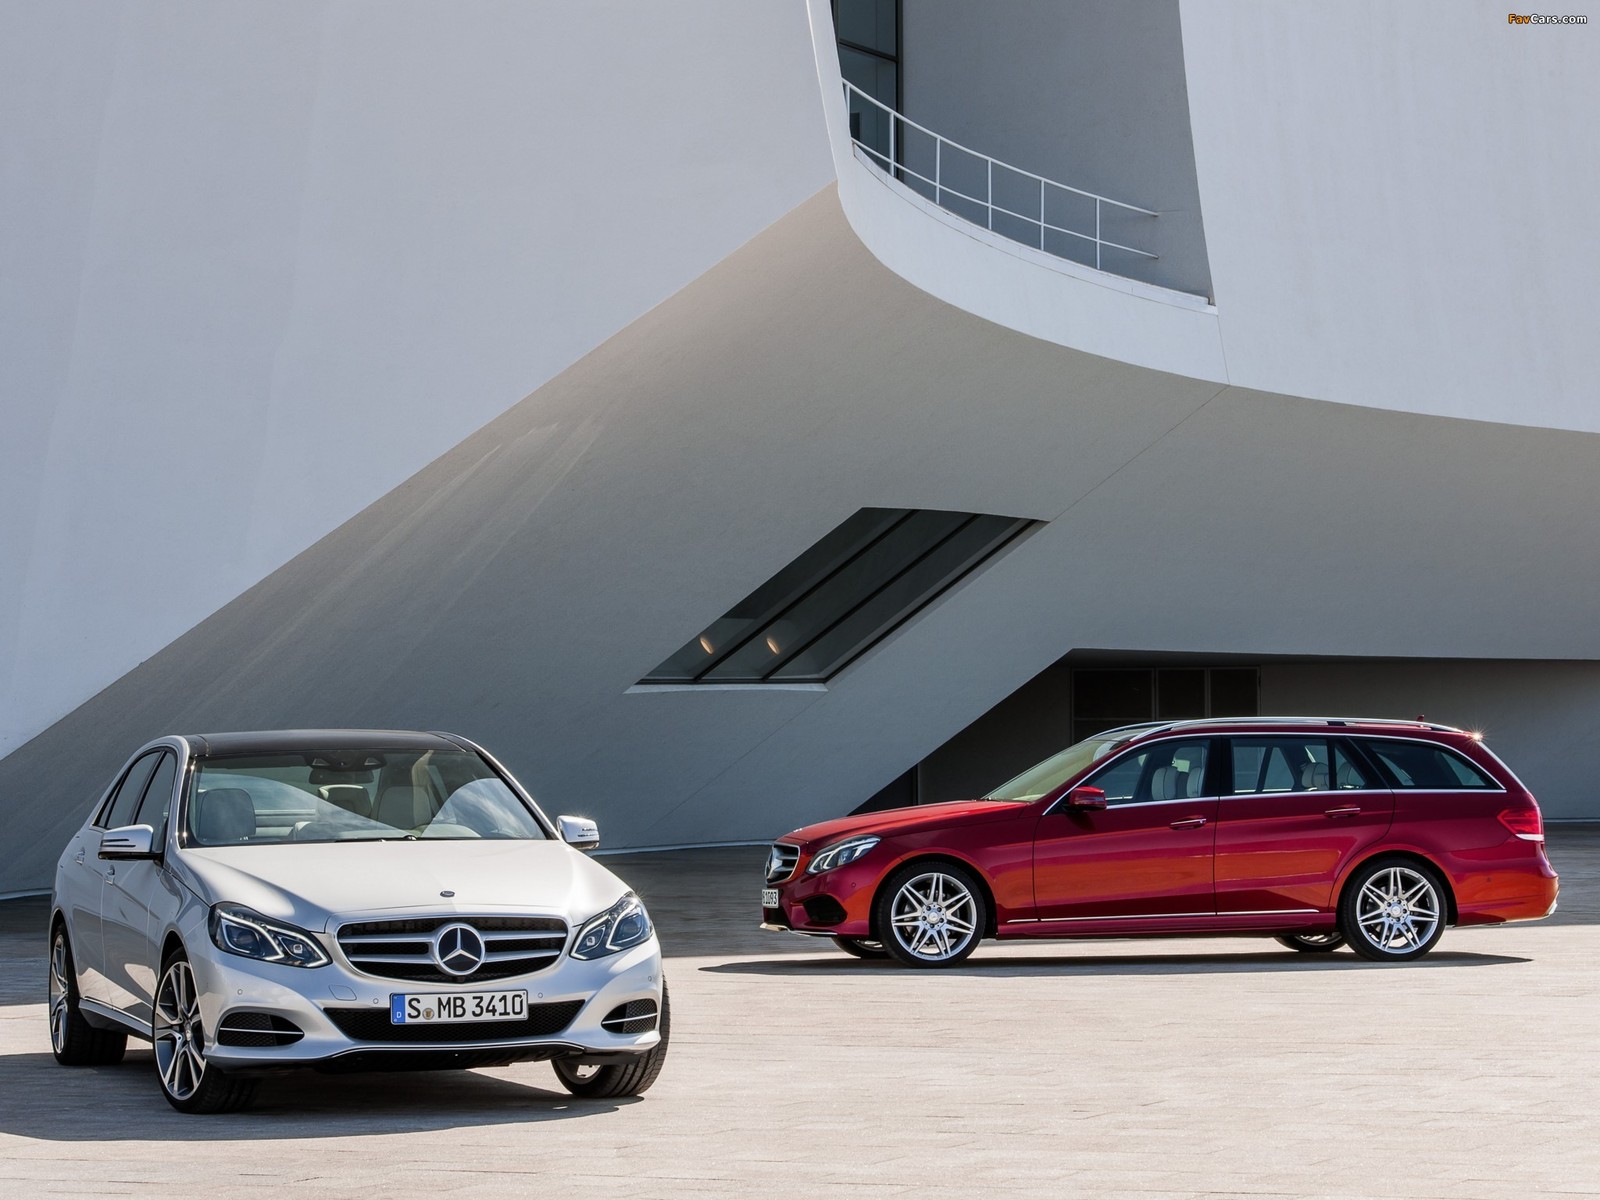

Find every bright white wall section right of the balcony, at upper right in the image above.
[1182,0,1600,430]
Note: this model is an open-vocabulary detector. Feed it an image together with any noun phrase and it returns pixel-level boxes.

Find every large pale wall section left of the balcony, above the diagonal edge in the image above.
[0,0,832,755]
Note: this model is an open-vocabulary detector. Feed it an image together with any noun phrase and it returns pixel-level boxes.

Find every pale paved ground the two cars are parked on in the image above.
[0,827,1600,1200]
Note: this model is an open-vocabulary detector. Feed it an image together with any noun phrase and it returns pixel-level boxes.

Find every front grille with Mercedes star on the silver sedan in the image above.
[338,917,568,984]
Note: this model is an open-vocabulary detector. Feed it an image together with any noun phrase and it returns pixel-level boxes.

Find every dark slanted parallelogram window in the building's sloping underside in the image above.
[642,509,1034,683]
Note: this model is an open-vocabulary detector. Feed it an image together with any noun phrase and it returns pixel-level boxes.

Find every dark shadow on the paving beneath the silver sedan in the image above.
[0,1045,638,1142]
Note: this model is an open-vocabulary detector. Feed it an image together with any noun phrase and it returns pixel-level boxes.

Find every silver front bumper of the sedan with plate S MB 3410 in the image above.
[187,936,664,1070]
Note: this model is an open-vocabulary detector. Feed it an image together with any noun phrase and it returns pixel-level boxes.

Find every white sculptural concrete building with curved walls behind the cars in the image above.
[0,0,1600,893]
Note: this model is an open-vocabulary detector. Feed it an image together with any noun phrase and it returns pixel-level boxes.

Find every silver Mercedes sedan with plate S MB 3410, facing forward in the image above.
[50,730,670,1112]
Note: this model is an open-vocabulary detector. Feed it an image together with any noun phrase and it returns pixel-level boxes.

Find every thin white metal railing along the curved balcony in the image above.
[845,80,1160,275]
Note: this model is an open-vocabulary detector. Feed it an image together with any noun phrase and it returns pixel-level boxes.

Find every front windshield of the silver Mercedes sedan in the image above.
[186,747,549,846]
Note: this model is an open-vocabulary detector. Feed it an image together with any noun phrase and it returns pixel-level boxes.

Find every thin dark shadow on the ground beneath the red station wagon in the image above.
[699,950,1531,978]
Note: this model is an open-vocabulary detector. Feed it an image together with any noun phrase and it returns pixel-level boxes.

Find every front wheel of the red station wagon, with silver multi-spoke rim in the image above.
[872,861,989,966]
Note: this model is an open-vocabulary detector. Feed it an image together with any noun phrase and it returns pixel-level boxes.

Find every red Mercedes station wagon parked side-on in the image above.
[762,717,1557,966]
